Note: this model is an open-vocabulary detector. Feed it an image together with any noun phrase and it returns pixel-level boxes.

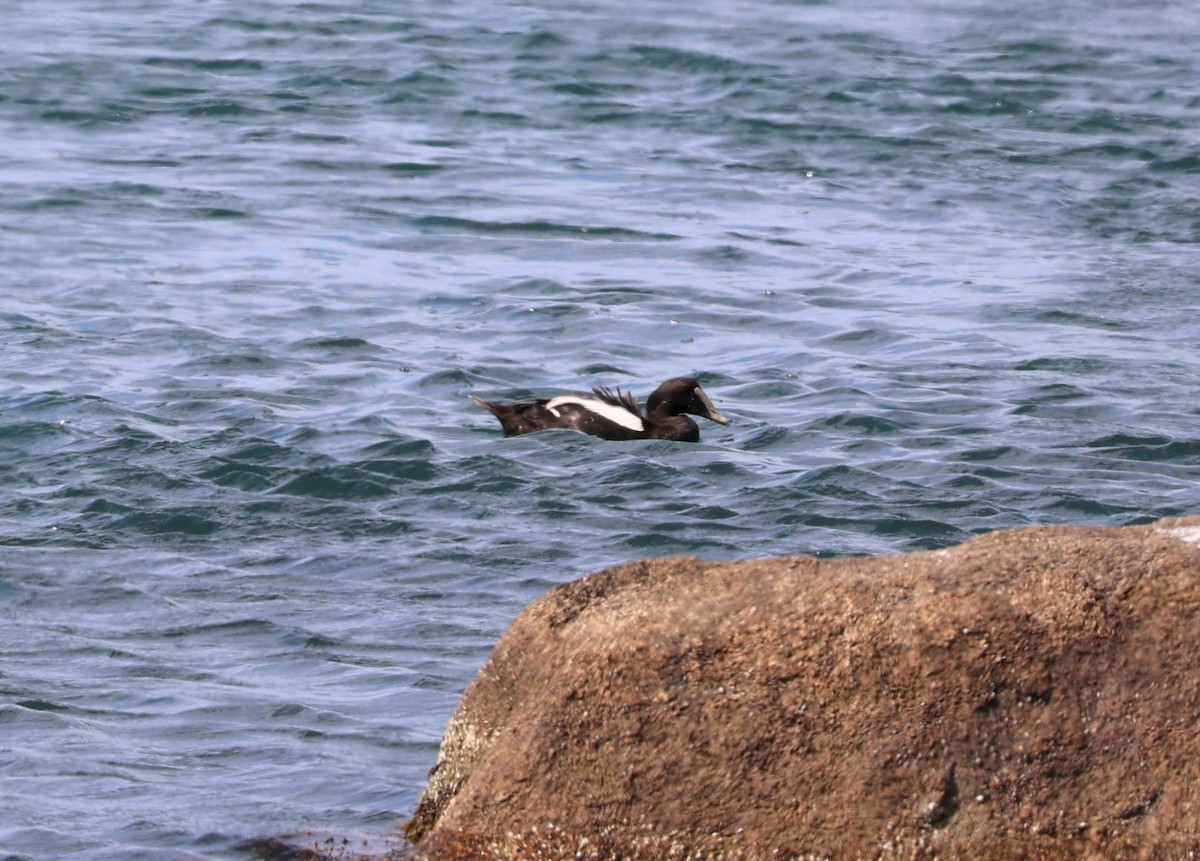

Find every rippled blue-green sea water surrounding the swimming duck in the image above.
[0,0,1200,861]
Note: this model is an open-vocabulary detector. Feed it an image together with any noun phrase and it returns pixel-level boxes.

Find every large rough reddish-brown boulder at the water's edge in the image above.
[408,517,1200,860]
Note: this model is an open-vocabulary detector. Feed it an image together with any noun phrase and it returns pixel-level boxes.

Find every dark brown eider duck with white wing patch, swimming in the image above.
[470,377,730,442]
